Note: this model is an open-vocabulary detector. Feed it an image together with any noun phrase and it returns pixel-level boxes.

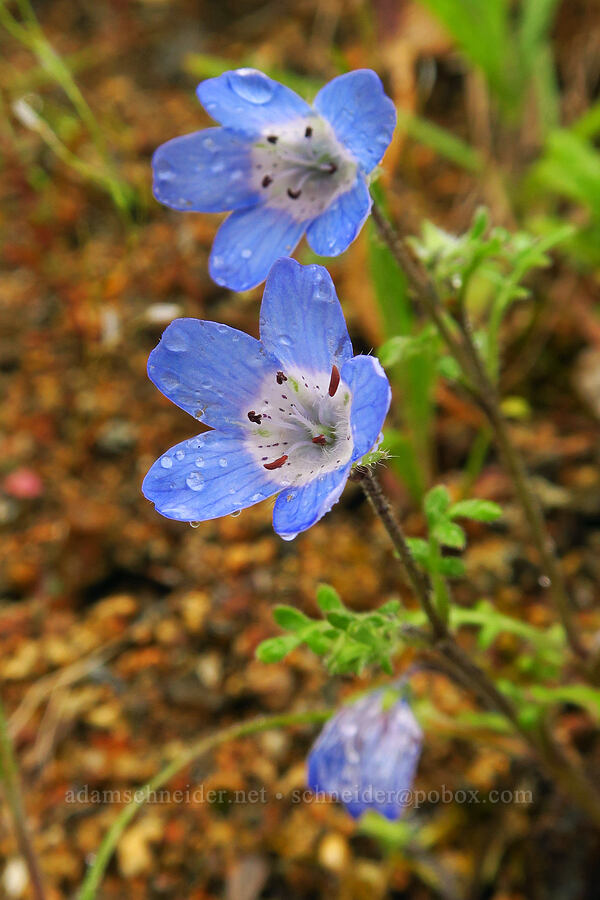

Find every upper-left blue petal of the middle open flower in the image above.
[148,319,278,433]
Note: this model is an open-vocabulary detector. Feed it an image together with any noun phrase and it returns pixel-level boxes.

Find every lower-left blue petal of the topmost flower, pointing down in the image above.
[209,206,305,291]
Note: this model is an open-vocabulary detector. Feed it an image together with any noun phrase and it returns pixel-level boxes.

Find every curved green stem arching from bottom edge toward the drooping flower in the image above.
[78,709,332,900]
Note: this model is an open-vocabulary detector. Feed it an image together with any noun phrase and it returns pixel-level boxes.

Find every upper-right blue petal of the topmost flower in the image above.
[314,69,396,173]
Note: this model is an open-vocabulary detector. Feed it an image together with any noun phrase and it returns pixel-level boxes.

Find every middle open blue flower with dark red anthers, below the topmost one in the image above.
[142,259,391,540]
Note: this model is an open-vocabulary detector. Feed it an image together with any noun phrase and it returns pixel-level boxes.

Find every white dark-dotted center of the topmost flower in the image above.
[251,114,357,222]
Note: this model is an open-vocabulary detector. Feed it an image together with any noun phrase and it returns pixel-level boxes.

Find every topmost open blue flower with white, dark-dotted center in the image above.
[152,69,396,291]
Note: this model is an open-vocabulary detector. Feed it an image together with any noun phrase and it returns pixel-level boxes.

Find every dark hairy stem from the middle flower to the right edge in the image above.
[354,466,600,828]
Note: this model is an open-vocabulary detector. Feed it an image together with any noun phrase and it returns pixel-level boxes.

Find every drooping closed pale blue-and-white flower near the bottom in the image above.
[308,691,423,820]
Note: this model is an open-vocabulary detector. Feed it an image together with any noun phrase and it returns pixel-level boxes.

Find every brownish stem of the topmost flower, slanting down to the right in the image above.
[372,203,588,660]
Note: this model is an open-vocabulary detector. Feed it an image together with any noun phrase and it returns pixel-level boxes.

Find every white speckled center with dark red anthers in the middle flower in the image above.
[246,366,353,487]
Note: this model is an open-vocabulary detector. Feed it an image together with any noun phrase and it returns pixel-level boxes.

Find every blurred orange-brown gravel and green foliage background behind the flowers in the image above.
[0,0,600,900]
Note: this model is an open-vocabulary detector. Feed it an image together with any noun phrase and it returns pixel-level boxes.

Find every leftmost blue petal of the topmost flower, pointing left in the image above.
[152,128,259,212]
